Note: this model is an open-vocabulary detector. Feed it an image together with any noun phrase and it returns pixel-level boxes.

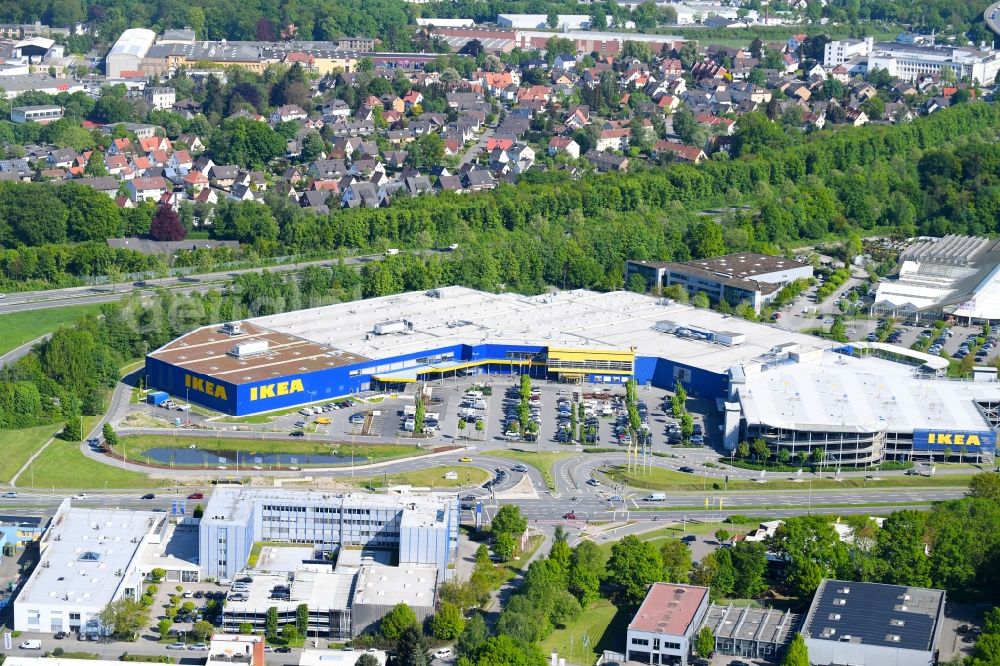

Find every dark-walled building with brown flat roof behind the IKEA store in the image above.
[625,252,813,314]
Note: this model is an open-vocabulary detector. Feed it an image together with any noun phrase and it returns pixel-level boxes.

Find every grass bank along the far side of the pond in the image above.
[118,435,427,467]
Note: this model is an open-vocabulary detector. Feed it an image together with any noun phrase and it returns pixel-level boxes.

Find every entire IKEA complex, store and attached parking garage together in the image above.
[146,287,1000,465]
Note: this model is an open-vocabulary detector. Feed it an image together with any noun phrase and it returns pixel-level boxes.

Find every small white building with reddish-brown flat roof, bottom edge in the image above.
[625,583,708,666]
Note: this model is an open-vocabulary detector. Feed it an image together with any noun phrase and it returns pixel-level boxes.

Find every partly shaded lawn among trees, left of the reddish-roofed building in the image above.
[538,599,634,664]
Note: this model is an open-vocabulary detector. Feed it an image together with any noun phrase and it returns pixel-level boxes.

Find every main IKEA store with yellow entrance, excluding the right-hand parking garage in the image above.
[146,287,829,415]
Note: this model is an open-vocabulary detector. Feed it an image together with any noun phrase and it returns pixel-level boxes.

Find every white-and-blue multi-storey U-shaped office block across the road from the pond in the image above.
[199,487,459,580]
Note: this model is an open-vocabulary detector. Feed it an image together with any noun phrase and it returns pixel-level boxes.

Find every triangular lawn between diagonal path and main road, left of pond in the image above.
[18,439,167,490]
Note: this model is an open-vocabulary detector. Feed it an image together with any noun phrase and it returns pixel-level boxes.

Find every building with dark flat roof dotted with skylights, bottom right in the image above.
[802,580,945,666]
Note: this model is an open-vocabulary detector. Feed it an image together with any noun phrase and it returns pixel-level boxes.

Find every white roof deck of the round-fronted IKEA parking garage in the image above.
[738,352,1000,433]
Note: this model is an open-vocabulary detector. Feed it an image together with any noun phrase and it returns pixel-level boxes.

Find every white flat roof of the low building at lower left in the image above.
[16,507,167,607]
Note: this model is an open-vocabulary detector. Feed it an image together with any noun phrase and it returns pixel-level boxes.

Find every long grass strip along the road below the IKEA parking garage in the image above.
[602,465,972,491]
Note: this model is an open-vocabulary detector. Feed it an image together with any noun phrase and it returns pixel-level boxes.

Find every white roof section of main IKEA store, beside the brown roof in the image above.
[250,287,830,373]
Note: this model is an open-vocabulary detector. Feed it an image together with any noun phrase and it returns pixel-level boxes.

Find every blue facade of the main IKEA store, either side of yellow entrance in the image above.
[146,343,729,416]
